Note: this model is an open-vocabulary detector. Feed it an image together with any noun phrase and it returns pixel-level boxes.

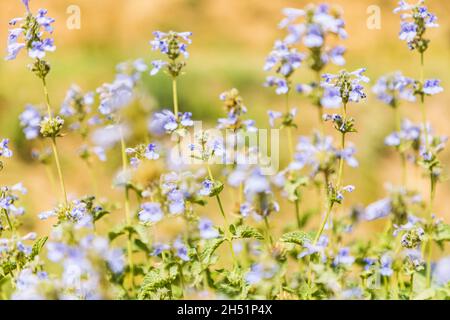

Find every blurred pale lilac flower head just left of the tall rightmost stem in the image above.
[372,71,415,108]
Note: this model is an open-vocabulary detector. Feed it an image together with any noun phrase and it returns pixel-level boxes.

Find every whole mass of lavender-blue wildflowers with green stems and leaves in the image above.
[0,0,450,299]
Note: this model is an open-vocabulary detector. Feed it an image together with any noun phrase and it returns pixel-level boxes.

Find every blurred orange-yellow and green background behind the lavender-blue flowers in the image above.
[0,0,450,248]
